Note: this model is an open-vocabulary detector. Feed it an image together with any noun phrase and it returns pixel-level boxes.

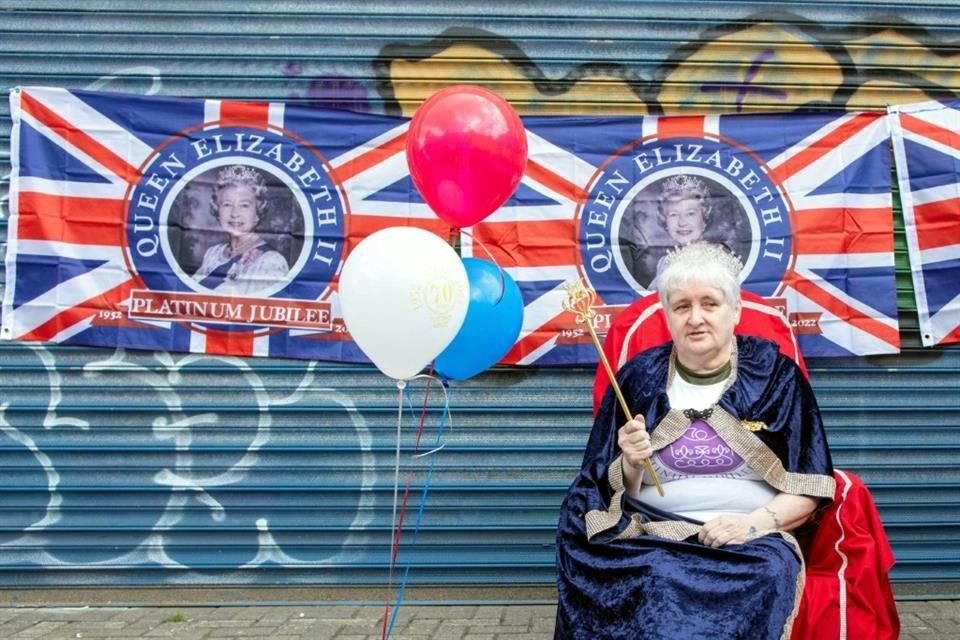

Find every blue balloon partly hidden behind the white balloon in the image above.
[434,258,523,380]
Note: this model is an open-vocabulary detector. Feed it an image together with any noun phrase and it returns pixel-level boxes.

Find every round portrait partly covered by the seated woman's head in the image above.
[618,173,750,291]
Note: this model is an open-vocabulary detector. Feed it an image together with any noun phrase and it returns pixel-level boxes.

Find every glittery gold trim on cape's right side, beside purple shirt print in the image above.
[707,405,837,498]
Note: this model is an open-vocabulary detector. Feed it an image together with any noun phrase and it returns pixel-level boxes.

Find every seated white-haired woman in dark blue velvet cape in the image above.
[556,244,834,640]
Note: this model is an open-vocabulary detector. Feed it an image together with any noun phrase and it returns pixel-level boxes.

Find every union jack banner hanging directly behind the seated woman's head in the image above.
[472,112,900,365]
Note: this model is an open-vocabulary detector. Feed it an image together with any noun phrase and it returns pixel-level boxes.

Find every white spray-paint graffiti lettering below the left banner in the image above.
[0,346,375,583]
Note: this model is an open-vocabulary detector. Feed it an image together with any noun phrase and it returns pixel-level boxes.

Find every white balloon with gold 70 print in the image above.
[340,227,470,380]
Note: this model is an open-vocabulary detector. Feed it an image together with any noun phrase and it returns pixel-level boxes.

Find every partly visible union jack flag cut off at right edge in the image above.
[890,100,960,347]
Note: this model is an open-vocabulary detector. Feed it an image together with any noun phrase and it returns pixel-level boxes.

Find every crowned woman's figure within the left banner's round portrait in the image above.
[193,164,290,295]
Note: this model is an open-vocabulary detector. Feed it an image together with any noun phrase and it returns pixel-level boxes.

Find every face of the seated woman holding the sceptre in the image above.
[666,282,740,373]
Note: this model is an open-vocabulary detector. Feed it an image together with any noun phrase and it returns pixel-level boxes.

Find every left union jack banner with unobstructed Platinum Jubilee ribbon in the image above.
[2,88,447,361]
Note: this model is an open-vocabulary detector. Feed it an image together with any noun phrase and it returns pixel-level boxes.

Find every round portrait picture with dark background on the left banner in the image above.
[171,164,303,295]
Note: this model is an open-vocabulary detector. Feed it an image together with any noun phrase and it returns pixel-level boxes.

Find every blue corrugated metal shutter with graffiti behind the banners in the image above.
[0,0,960,589]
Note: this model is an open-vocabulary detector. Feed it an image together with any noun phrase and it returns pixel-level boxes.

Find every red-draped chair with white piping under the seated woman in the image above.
[593,291,900,640]
